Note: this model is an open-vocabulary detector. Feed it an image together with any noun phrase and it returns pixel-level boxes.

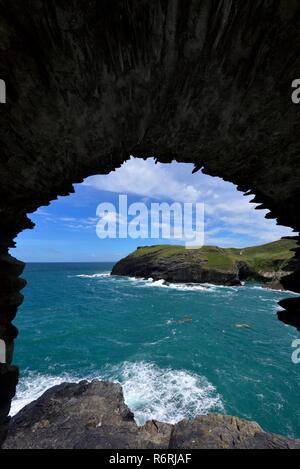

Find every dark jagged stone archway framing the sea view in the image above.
[0,0,300,444]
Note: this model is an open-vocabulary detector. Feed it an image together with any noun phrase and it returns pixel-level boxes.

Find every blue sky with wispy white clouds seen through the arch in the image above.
[11,158,293,262]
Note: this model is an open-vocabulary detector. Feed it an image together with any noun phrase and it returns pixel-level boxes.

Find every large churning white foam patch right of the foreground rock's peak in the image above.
[104,362,224,425]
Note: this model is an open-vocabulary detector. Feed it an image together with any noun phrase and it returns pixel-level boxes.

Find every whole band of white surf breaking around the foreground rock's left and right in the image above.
[11,362,224,425]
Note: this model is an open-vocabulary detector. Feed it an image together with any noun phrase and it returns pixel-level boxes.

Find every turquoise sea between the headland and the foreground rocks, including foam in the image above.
[12,264,300,437]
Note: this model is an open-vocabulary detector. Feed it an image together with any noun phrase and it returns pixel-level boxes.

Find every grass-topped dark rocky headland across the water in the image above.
[112,239,296,289]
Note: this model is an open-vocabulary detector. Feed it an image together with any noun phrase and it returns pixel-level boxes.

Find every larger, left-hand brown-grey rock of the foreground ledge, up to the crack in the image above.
[4,381,172,449]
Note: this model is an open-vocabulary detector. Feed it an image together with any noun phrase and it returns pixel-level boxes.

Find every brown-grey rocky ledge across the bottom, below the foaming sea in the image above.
[3,381,300,449]
